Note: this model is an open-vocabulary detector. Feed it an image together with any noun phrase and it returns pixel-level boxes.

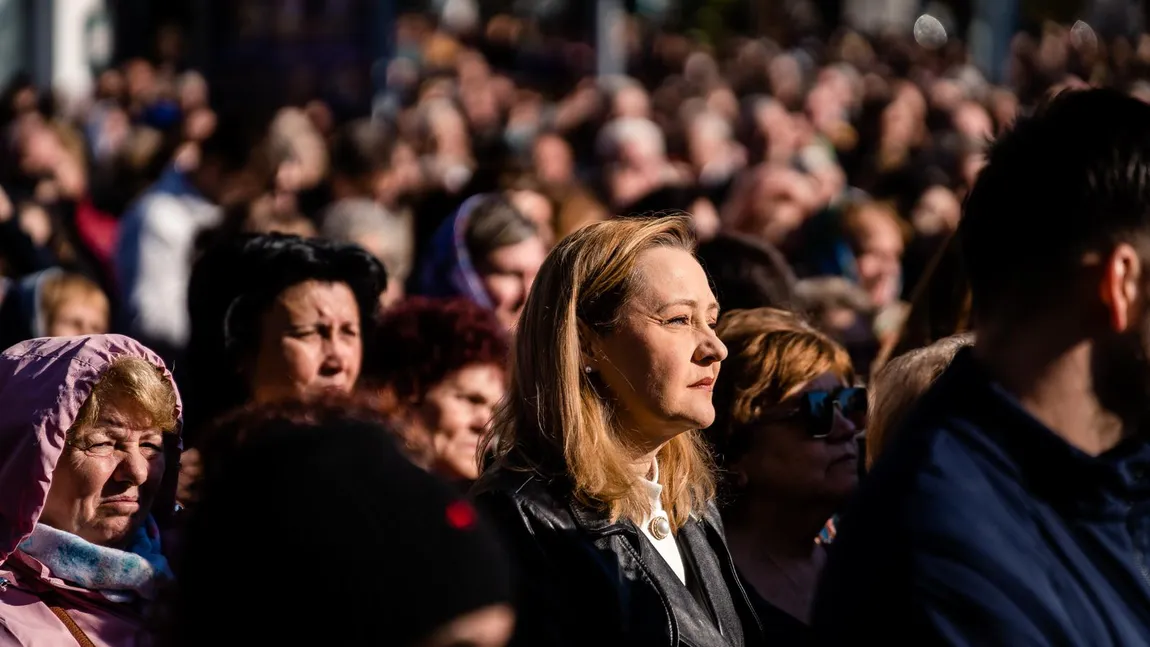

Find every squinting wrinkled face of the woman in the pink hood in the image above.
[40,401,164,547]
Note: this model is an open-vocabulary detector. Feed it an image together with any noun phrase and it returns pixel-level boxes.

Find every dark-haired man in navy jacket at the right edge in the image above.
[814,90,1150,646]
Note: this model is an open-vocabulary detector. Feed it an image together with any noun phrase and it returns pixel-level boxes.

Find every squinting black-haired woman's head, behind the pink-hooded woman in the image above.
[181,233,386,433]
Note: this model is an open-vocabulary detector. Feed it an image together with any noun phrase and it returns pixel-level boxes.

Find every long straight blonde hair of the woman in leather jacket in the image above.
[481,216,715,527]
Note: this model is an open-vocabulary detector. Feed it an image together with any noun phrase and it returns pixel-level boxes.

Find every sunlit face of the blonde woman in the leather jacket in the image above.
[585,247,727,445]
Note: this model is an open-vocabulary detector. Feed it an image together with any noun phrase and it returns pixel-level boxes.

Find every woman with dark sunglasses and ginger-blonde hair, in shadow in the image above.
[708,308,867,646]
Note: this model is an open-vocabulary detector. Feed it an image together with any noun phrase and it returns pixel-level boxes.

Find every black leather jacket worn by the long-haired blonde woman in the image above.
[474,470,764,647]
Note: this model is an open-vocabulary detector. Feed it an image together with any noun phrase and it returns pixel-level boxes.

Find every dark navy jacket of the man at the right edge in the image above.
[814,349,1150,647]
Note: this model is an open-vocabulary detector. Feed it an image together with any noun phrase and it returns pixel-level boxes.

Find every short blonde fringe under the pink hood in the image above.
[68,357,179,437]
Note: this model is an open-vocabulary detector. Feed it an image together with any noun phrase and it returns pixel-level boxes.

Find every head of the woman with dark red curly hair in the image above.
[366,296,509,483]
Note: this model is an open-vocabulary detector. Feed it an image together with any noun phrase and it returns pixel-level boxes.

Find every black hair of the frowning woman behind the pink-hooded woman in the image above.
[181,233,386,446]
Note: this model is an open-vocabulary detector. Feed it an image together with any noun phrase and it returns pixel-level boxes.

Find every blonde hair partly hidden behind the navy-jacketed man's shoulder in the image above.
[866,333,974,469]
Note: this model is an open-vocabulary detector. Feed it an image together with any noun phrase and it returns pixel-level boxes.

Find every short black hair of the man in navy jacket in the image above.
[959,90,1150,321]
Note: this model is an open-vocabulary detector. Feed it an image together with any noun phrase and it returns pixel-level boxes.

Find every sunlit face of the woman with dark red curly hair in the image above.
[416,364,505,480]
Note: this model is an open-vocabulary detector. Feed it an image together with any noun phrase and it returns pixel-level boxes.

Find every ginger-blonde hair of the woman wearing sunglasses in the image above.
[711,308,854,461]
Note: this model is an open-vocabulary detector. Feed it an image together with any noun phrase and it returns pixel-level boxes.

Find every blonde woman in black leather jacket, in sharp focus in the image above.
[476,217,762,647]
